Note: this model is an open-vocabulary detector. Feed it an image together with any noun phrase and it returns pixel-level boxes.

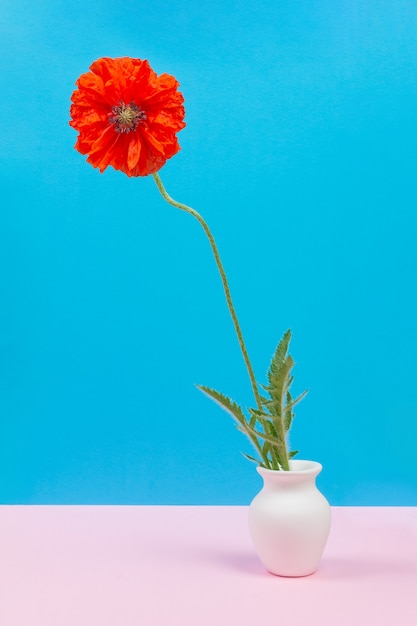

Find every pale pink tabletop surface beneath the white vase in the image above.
[0,506,417,626]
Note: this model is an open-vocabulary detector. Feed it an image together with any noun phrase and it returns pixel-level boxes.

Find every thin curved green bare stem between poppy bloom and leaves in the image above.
[153,173,262,410]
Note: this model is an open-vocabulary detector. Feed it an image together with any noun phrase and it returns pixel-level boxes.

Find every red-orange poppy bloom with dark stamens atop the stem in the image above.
[70,57,185,176]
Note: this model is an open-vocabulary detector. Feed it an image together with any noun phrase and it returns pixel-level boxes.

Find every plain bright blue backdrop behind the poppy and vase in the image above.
[0,0,417,505]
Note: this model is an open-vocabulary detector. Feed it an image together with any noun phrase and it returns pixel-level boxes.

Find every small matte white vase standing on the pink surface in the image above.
[249,461,330,576]
